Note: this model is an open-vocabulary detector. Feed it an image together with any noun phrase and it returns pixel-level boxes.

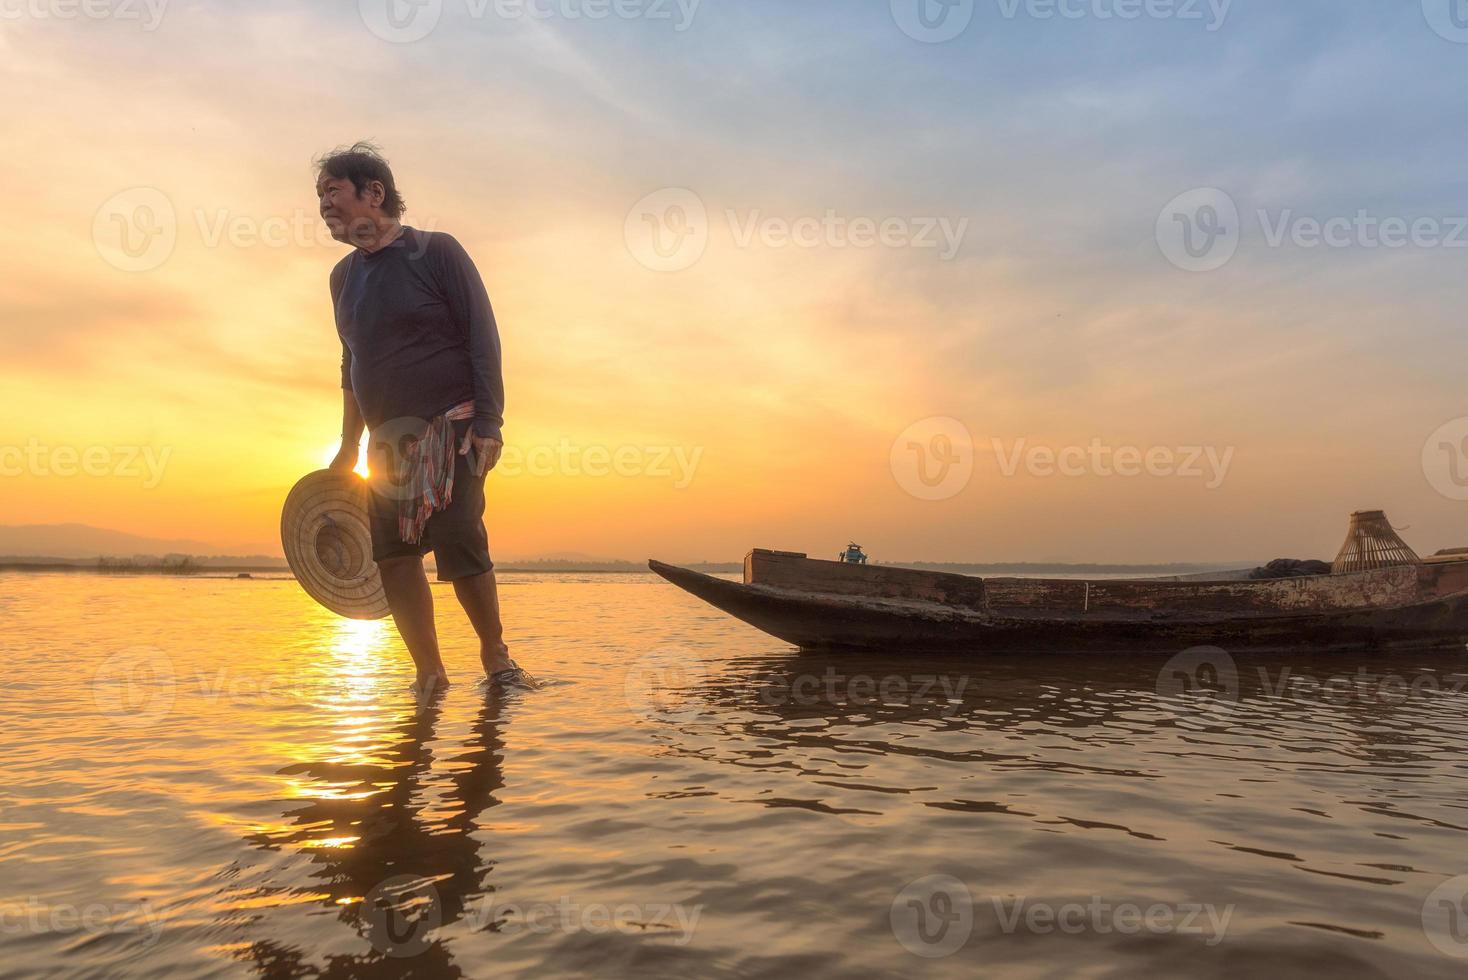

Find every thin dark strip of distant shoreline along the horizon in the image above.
[0,555,1255,578]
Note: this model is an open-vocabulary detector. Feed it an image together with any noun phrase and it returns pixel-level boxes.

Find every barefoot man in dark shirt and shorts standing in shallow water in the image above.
[316,142,536,694]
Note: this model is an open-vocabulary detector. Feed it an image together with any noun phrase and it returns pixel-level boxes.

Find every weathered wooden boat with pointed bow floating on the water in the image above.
[649,549,1468,653]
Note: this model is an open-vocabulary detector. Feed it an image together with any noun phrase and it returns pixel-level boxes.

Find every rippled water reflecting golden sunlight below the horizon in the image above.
[0,574,1468,979]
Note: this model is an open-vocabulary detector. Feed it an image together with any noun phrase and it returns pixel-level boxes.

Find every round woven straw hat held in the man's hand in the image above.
[280,469,388,619]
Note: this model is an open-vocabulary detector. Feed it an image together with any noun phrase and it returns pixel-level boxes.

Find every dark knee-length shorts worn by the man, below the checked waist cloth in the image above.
[367,418,495,582]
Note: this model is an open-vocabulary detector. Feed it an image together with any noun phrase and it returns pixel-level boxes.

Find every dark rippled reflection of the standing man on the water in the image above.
[226,691,505,977]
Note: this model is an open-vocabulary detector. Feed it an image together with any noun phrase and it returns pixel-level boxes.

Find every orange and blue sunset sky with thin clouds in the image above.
[0,0,1468,562]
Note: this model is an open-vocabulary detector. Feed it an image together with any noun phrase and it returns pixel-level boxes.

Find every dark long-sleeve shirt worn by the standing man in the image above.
[332,226,505,440]
